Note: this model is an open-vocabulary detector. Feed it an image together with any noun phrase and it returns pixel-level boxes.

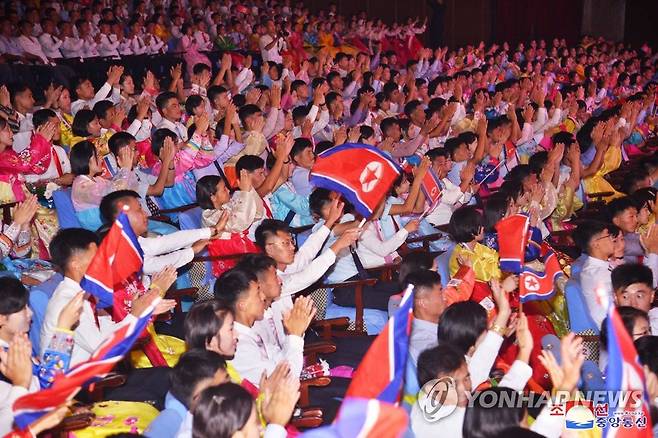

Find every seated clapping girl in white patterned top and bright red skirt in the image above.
[196,170,263,277]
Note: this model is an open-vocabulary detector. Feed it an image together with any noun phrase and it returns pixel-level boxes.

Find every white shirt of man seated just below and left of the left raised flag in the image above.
[40,277,134,366]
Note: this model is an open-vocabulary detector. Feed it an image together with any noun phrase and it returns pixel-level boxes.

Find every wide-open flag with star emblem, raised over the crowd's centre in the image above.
[310,143,402,218]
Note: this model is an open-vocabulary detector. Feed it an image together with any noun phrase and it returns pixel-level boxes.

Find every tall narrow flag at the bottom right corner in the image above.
[603,300,653,438]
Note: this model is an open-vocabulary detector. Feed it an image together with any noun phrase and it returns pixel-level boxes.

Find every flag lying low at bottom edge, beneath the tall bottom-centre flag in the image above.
[302,397,409,438]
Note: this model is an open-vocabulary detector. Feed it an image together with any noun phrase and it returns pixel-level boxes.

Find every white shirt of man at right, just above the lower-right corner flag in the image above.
[580,257,613,328]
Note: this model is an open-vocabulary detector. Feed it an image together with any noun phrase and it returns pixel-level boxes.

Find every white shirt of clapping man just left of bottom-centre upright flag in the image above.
[231,322,304,385]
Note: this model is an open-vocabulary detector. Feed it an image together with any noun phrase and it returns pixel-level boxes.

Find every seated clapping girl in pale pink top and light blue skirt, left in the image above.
[71,140,139,231]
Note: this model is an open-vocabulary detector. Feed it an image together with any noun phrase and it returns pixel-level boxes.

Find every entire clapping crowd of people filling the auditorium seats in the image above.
[0,0,658,438]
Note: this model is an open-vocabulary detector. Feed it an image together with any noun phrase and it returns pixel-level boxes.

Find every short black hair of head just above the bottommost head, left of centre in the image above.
[169,348,226,409]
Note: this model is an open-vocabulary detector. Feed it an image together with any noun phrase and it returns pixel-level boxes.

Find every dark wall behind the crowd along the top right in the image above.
[305,0,658,47]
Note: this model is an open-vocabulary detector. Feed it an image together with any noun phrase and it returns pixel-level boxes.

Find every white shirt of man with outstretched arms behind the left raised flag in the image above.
[137,228,212,275]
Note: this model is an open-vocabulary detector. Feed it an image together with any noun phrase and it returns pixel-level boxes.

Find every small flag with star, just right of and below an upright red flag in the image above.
[519,245,564,303]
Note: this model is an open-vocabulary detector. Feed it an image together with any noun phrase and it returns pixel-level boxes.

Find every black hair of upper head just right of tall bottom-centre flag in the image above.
[437,301,487,355]
